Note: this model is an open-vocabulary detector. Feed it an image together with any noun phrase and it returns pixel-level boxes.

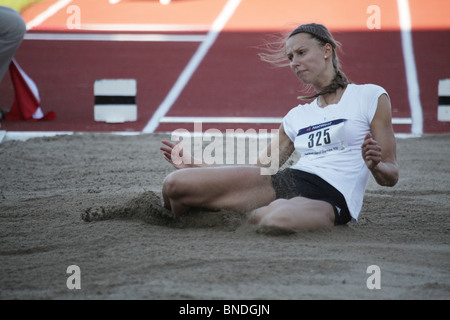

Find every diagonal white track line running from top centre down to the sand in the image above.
[142,0,241,133]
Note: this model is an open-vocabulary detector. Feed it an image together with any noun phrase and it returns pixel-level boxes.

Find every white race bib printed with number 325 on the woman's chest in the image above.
[295,119,347,157]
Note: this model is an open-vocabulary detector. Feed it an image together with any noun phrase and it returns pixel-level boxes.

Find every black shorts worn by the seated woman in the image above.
[272,168,352,225]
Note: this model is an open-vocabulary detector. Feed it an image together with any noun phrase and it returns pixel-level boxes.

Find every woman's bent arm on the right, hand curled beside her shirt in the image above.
[361,94,399,187]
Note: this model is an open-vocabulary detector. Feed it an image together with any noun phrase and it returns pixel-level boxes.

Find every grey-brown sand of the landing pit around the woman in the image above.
[0,134,450,300]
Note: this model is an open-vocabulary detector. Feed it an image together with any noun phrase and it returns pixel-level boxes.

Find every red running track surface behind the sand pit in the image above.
[0,0,450,133]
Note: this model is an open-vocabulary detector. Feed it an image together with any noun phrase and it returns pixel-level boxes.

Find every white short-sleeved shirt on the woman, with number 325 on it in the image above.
[283,84,387,220]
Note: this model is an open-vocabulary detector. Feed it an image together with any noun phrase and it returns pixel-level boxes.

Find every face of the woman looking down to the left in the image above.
[286,33,331,84]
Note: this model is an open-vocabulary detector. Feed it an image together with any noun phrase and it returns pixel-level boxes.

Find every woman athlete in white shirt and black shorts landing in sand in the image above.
[161,23,399,231]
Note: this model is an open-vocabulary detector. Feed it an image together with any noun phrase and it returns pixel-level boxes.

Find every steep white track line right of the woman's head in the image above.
[397,0,423,134]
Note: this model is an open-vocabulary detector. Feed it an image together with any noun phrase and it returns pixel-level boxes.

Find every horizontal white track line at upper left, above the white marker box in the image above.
[25,32,206,42]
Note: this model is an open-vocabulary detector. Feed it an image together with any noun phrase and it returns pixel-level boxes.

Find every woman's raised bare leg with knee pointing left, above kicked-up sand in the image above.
[162,166,275,214]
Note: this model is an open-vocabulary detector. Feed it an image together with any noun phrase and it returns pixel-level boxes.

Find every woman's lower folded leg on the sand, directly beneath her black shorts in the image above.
[249,197,334,231]
